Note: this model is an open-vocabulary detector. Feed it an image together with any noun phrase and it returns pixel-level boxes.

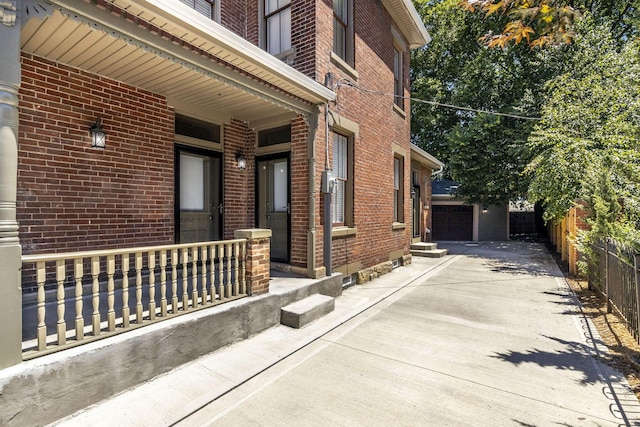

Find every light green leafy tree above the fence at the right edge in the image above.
[528,19,640,244]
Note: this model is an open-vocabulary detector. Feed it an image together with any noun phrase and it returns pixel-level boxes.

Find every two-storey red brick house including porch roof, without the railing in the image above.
[0,0,437,288]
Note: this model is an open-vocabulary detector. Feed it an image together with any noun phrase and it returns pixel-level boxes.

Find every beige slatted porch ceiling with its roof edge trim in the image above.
[21,0,332,124]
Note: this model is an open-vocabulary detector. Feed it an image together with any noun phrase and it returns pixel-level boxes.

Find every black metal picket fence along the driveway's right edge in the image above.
[587,239,640,342]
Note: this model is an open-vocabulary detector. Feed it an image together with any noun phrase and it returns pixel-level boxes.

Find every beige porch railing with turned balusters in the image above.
[22,239,247,360]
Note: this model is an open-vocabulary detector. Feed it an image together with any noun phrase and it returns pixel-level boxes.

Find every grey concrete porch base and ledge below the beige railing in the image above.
[0,247,342,425]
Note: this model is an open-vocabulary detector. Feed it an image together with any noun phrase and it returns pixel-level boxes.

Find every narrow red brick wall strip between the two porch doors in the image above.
[224,120,255,239]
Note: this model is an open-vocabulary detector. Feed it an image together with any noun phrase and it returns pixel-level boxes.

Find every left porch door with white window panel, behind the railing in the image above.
[176,148,222,243]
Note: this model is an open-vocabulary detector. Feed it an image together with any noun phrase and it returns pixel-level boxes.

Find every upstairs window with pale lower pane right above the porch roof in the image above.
[264,0,291,55]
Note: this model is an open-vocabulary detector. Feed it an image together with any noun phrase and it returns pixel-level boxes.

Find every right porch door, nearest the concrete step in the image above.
[256,156,291,263]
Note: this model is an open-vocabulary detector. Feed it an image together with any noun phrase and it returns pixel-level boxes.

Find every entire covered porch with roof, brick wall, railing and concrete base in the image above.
[0,0,342,422]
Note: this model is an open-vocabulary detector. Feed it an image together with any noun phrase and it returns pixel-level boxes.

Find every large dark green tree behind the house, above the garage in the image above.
[411,0,556,204]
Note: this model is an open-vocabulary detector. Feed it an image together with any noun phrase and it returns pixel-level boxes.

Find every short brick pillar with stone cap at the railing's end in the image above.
[235,228,271,295]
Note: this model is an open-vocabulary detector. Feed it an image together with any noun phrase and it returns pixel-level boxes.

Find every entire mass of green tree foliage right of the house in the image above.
[411,0,640,241]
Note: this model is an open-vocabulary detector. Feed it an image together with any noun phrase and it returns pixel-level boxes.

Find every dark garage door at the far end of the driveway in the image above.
[431,205,473,241]
